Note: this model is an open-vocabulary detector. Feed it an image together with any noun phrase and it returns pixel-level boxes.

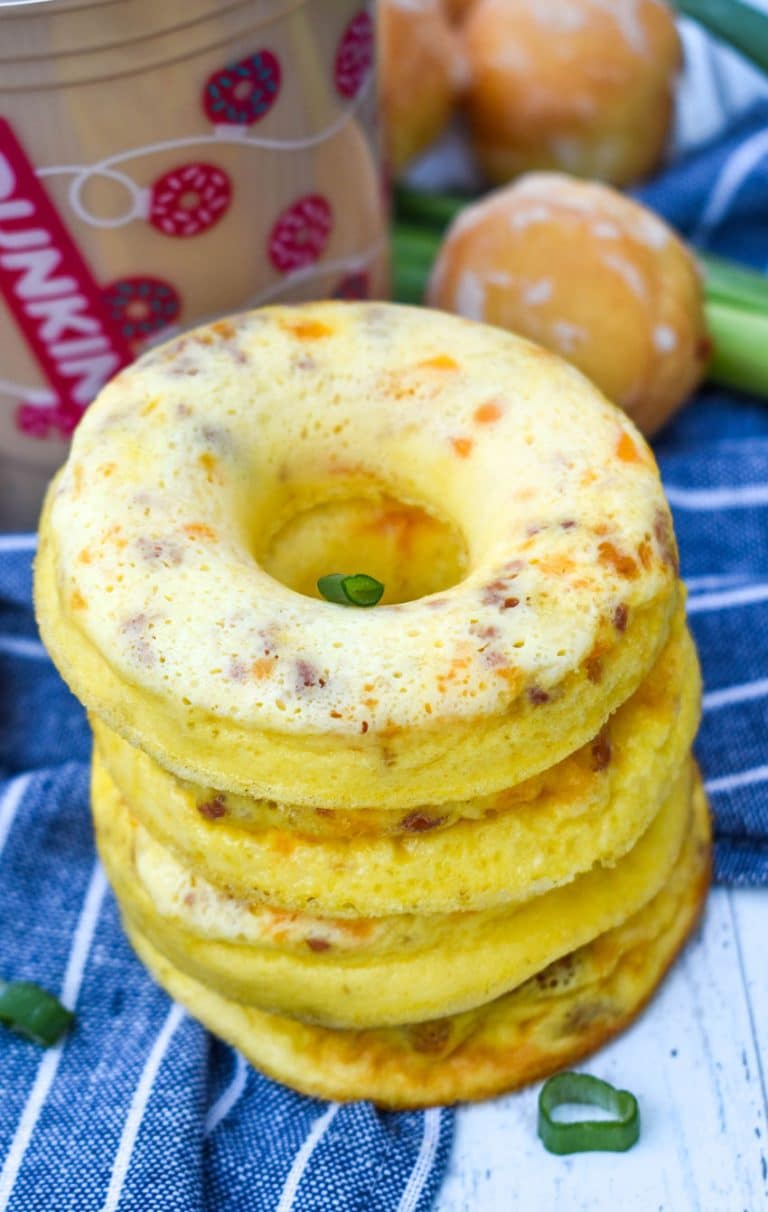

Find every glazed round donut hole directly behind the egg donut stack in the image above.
[428,173,711,434]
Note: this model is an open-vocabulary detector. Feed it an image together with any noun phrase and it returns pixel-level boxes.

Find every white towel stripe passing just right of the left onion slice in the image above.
[0,859,107,1212]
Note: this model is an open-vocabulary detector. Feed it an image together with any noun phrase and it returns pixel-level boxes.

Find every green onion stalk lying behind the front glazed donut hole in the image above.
[392,186,768,398]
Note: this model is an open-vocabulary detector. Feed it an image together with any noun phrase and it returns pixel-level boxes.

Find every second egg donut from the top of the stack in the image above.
[92,610,700,911]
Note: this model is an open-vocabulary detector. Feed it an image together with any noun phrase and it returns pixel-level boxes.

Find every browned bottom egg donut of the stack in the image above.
[126,781,710,1108]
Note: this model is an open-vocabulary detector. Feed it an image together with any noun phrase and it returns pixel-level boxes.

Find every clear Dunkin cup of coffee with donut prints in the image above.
[0,0,388,531]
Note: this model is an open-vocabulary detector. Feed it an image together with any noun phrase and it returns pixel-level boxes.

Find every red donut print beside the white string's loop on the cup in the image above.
[149,164,233,236]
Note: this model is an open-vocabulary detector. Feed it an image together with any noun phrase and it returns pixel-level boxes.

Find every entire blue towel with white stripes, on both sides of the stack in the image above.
[0,107,768,1212]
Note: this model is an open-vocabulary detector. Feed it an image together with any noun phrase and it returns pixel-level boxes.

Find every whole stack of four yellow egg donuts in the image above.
[35,303,710,1107]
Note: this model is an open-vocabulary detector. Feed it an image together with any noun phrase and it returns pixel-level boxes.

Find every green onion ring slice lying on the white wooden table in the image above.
[538,1073,640,1154]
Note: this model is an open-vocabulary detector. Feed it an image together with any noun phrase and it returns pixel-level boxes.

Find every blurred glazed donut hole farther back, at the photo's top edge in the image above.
[463,0,681,185]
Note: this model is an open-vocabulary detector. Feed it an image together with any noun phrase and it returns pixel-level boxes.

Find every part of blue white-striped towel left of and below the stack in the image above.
[0,536,453,1212]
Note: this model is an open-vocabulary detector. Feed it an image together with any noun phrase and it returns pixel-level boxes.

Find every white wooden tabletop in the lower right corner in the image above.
[436,888,768,1212]
